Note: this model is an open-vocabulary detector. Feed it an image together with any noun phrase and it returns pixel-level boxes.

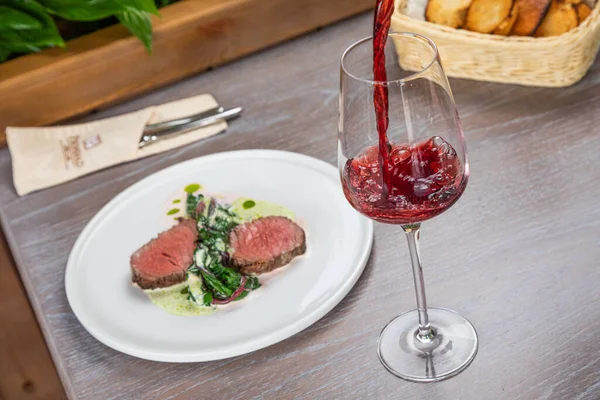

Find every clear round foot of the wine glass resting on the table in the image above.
[377,308,478,382]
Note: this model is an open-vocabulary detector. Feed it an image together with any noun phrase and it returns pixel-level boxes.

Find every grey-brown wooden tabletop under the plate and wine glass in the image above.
[0,15,600,400]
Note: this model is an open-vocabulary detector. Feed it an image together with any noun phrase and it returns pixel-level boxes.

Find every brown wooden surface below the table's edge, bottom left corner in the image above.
[0,231,66,400]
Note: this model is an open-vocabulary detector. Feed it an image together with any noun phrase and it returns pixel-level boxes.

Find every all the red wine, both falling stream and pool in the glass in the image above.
[342,0,468,224]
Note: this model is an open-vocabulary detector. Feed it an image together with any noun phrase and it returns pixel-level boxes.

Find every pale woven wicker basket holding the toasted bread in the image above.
[391,0,600,87]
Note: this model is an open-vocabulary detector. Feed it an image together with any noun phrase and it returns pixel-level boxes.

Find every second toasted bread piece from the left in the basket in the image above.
[465,0,513,33]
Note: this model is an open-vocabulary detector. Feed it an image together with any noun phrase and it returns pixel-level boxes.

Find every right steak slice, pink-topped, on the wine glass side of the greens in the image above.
[229,217,306,274]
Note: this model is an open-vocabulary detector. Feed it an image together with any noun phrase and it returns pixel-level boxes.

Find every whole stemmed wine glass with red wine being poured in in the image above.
[338,33,478,382]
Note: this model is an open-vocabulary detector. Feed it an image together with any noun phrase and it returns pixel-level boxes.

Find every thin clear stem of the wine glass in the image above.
[402,224,436,344]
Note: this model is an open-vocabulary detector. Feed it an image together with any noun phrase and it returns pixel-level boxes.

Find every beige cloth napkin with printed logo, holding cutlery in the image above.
[6,94,227,196]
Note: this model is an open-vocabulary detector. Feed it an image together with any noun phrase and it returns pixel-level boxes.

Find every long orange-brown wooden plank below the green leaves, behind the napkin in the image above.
[0,0,374,146]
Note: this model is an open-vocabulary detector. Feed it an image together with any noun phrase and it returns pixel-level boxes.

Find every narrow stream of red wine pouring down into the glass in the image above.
[373,0,394,195]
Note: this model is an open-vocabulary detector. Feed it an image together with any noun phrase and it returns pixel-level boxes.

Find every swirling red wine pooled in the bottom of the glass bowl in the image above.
[342,136,467,224]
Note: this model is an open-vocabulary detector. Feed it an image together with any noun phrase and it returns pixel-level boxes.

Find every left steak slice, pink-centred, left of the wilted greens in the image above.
[130,219,198,289]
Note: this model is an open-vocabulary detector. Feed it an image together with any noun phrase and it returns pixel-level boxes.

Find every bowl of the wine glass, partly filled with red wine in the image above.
[338,33,469,224]
